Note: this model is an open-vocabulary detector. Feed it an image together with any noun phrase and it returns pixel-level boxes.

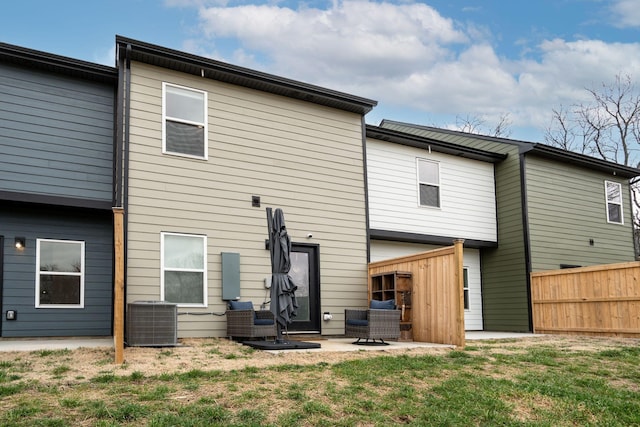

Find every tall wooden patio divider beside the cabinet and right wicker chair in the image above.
[369,240,465,347]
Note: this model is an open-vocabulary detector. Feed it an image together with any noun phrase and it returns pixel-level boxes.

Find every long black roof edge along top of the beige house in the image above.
[116,36,377,115]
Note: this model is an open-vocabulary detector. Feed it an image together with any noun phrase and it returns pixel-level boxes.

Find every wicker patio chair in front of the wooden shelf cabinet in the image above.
[344,309,400,345]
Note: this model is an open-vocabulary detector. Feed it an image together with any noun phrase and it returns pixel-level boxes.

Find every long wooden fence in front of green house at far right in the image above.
[531,262,640,338]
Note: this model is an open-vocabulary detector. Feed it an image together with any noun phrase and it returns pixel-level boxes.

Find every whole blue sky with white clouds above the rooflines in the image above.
[0,0,640,142]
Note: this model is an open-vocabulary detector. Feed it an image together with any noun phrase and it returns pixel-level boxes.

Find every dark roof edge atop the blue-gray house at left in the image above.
[0,42,118,83]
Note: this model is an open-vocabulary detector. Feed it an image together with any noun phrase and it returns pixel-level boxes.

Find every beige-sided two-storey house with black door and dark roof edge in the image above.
[117,37,375,337]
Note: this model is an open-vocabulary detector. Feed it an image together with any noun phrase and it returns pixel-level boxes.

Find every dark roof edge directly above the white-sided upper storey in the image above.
[367,125,507,163]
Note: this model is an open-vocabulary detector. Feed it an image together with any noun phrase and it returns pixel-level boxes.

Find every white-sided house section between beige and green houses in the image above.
[366,125,506,330]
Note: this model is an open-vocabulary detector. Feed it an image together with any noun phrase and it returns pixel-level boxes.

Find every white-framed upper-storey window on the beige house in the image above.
[162,83,207,159]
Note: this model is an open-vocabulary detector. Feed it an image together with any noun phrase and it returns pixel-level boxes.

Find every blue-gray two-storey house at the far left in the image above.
[0,43,118,337]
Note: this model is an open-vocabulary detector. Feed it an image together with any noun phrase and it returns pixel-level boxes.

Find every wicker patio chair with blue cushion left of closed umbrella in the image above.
[227,302,277,339]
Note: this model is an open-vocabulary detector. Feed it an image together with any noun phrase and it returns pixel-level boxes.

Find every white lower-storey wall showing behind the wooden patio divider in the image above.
[371,240,482,331]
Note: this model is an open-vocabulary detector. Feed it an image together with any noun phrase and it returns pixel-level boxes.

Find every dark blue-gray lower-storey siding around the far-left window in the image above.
[0,205,113,337]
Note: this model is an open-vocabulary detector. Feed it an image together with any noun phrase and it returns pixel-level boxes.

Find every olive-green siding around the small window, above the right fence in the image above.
[526,156,634,271]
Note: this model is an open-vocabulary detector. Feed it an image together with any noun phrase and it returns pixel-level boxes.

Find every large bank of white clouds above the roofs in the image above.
[181,0,640,140]
